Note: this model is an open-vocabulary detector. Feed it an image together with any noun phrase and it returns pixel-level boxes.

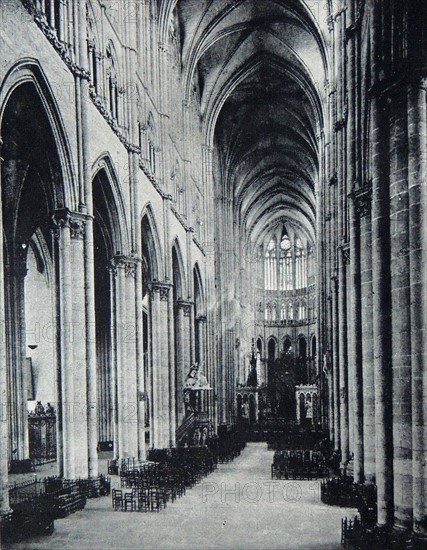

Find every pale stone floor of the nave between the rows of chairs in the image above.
[5,443,356,550]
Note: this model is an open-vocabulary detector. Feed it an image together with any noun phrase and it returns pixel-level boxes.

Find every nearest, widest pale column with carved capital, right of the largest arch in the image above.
[54,209,89,479]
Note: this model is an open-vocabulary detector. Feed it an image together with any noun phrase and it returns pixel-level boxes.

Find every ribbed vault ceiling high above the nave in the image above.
[169,0,327,248]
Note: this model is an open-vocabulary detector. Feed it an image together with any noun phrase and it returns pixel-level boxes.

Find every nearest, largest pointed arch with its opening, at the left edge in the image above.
[0,66,73,470]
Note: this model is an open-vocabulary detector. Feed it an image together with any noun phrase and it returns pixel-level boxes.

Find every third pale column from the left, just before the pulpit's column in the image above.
[151,283,170,448]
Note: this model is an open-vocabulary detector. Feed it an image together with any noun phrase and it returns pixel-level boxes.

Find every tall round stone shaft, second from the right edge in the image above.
[389,92,412,529]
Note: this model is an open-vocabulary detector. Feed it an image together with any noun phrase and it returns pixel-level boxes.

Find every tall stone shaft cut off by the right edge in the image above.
[408,79,427,548]
